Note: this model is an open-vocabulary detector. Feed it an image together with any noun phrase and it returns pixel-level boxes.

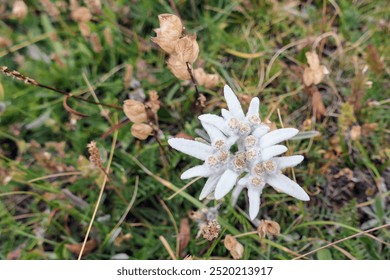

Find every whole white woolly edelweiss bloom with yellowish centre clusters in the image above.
[168,86,309,220]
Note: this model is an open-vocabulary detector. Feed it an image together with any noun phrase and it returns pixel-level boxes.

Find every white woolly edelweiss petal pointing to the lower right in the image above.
[266,174,310,201]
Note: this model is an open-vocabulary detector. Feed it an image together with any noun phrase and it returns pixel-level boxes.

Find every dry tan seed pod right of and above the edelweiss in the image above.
[303,52,329,87]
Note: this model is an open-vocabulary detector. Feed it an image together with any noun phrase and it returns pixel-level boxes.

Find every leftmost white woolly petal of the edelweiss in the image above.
[168,138,213,160]
